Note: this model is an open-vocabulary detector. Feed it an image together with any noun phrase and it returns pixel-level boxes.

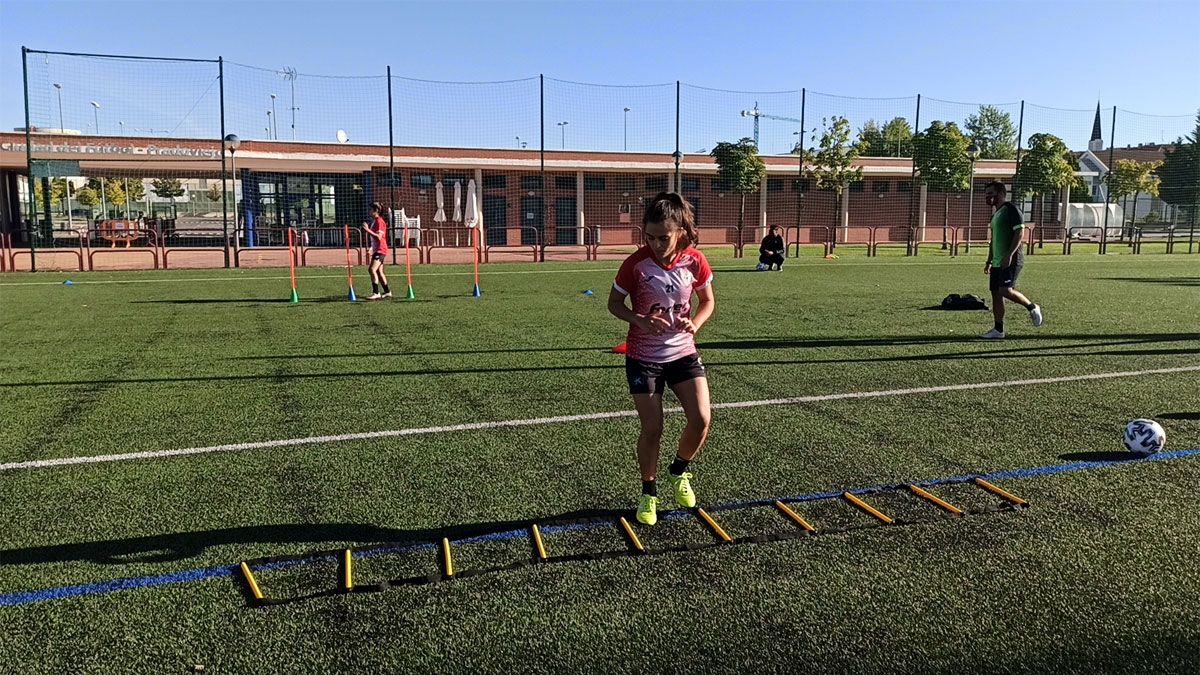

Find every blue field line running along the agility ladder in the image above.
[0,448,1200,607]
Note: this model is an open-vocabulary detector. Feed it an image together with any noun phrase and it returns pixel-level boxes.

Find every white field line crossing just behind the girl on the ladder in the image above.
[0,365,1200,472]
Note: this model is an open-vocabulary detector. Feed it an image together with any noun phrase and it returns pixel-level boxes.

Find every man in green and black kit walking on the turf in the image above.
[982,180,1042,340]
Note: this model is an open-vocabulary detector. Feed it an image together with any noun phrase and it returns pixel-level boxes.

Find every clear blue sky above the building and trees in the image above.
[0,0,1200,153]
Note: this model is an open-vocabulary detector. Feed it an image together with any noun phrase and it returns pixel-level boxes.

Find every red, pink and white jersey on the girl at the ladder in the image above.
[612,246,713,363]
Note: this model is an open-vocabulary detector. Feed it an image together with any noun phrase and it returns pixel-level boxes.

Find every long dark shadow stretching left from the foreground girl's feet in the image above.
[0,509,632,566]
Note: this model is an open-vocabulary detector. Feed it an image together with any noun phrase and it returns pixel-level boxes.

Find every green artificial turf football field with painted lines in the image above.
[0,251,1200,673]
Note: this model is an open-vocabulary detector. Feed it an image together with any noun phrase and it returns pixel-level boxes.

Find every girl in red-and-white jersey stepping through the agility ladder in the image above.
[608,192,716,525]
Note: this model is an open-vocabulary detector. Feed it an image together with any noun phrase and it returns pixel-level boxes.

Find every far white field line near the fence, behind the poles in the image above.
[0,256,1193,283]
